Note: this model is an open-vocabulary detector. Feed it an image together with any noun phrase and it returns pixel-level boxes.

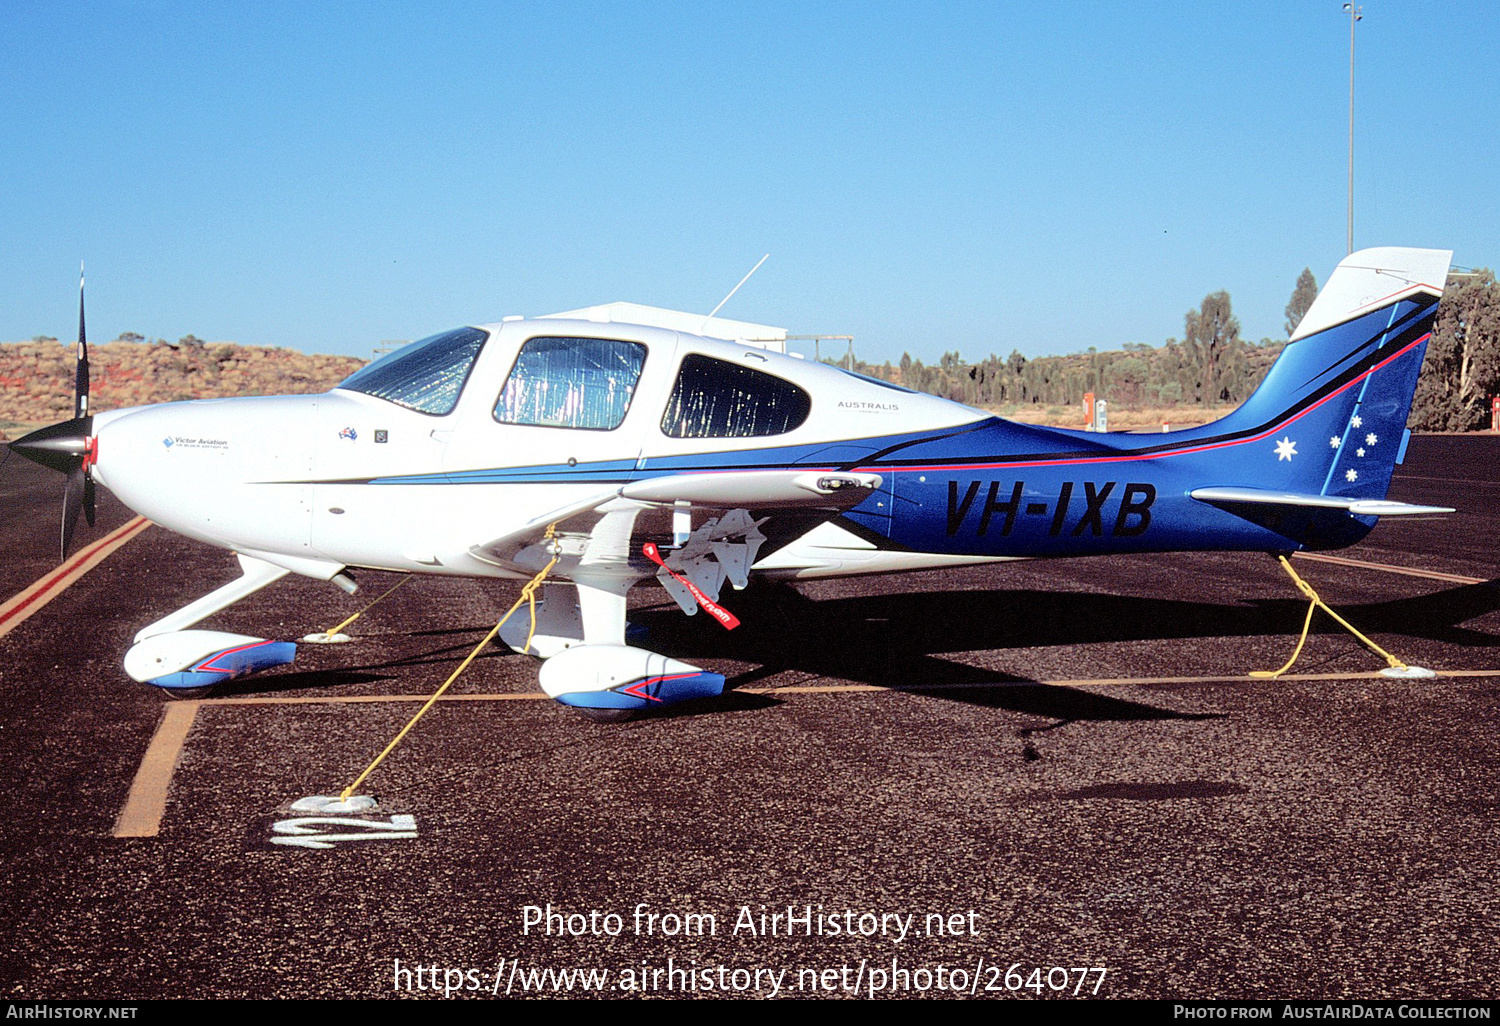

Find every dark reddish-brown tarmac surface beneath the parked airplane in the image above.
[0,437,1500,1001]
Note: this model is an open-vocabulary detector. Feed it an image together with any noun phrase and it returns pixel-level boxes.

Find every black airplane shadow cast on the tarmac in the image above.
[213,584,1500,723]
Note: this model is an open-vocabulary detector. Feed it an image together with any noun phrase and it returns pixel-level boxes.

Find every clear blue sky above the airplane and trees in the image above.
[0,0,1500,362]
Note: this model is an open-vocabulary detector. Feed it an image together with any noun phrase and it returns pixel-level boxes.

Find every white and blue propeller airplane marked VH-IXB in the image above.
[11,249,1451,716]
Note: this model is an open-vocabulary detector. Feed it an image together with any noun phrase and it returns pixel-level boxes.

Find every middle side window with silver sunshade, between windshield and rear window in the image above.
[495,338,647,431]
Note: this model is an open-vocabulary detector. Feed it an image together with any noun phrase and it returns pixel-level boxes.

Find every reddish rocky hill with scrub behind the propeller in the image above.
[0,336,365,437]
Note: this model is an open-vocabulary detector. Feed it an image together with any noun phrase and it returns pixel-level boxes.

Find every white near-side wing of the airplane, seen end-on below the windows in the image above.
[470,470,882,573]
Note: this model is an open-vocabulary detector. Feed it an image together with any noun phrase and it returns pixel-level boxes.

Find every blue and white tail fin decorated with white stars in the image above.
[1203,249,1452,500]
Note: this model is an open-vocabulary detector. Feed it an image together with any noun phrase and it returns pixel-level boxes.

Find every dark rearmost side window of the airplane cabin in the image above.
[662,353,813,438]
